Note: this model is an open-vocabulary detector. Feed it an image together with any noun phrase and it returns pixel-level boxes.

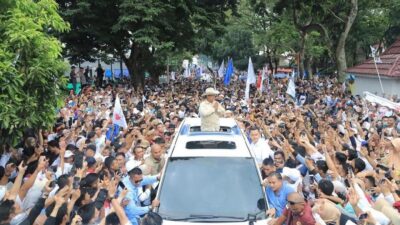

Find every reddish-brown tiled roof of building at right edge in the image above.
[346,38,400,77]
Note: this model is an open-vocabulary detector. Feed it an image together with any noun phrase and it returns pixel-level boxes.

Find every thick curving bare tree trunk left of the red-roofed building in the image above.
[336,0,358,81]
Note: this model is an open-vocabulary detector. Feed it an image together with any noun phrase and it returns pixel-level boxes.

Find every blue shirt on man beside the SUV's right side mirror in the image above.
[265,182,294,218]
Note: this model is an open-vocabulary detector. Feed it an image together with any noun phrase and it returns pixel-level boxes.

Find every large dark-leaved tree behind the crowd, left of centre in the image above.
[58,0,236,86]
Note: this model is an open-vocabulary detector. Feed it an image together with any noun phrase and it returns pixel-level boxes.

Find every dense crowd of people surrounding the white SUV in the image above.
[0,71,400,225]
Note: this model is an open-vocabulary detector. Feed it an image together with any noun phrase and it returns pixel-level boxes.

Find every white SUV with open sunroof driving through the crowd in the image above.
[157,118,267,225]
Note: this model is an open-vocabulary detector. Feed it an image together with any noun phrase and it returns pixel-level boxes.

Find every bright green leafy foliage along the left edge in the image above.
[0,0,69,144]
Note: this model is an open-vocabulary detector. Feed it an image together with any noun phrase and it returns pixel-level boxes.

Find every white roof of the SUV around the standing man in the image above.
[169,118,252,157]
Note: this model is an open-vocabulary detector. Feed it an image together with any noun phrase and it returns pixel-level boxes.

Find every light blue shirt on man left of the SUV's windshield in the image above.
[122,176,157,225]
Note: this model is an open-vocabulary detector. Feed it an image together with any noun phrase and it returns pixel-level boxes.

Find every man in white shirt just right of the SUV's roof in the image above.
[250,127,274,167]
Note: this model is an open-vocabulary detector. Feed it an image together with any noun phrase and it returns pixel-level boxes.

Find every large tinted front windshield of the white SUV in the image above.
[158,157,266,222]
